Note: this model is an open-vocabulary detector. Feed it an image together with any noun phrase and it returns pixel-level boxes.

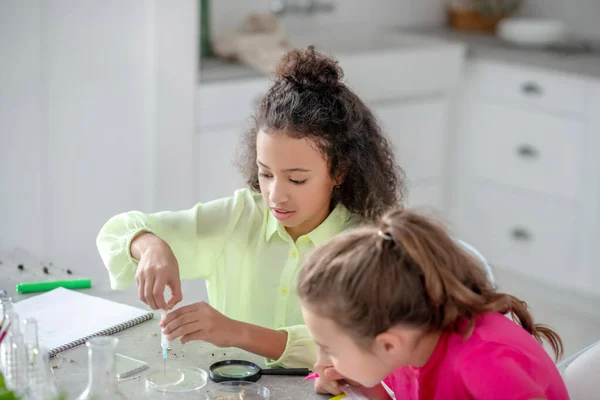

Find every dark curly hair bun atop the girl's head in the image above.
[275,46,344,89]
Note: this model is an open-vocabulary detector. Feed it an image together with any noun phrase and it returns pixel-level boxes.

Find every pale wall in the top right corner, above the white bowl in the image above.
[523,0,600,40]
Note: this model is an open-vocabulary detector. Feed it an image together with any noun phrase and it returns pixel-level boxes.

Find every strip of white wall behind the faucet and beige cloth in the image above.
[210,0,445,35]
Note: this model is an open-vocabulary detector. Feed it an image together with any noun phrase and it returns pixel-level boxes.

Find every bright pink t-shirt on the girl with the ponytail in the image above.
[384,313,569,400]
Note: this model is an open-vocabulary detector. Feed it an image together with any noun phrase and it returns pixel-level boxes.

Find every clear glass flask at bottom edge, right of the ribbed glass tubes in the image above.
[77,336,127,400]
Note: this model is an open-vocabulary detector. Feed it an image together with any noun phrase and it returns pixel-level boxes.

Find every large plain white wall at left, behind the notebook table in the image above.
[0,0,198,279]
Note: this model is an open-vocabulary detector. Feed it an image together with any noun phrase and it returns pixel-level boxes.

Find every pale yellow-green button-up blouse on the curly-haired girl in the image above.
[97,189,361,367]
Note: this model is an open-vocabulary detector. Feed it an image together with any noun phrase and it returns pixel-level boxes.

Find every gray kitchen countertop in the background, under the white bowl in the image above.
[200,23,600,83]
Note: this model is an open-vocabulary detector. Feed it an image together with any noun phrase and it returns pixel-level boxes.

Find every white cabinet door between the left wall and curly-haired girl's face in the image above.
[194,125,246,202]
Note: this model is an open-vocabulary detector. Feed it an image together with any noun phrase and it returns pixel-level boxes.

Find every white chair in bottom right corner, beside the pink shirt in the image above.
[557,341,600,400]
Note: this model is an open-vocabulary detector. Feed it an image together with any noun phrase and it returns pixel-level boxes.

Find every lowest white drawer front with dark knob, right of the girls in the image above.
[457,185,577,286]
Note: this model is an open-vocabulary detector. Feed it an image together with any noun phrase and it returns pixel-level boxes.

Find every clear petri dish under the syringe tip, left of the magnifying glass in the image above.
[146,366,208,393]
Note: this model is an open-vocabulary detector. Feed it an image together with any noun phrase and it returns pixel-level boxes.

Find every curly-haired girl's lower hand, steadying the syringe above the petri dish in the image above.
[160,302,238,347]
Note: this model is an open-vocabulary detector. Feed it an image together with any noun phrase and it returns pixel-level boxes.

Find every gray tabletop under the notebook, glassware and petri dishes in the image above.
[0,253,328,400]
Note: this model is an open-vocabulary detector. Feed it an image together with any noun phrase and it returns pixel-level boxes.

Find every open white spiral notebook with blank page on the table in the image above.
[14,288,154,357]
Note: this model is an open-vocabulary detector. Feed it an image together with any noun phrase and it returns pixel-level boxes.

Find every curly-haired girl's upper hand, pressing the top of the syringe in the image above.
[131,233,182,310]
